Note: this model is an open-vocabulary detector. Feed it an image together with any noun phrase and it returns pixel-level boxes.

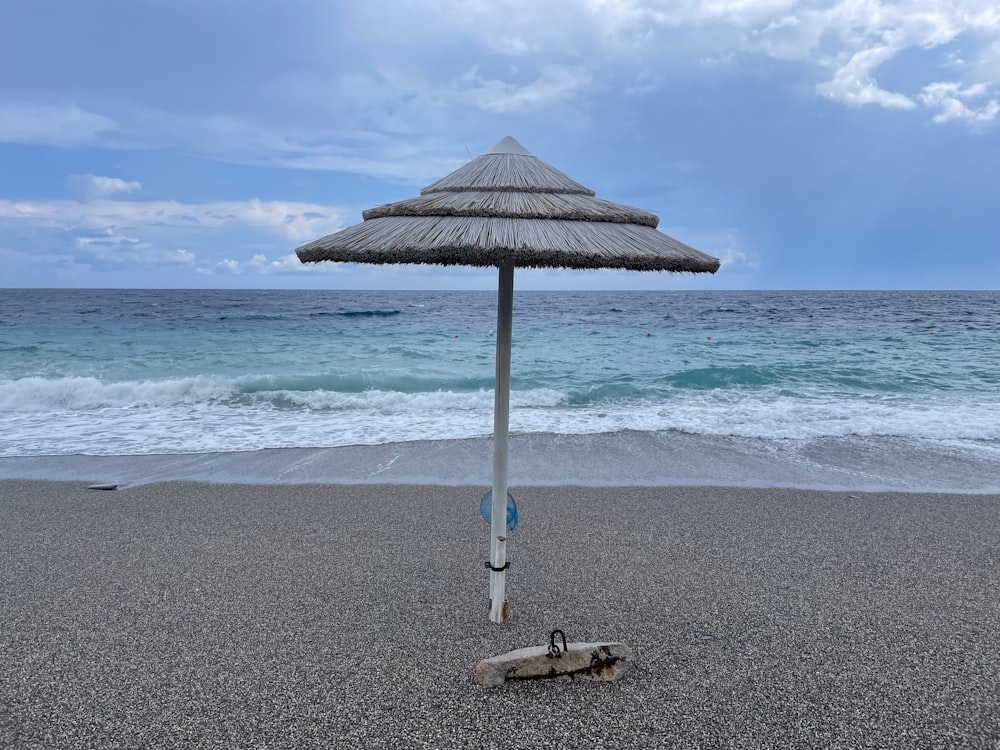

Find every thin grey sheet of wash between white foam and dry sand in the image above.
[0,431,1000,494]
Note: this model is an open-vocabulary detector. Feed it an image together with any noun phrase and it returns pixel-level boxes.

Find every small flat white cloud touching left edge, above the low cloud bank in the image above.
[0,102,118,146]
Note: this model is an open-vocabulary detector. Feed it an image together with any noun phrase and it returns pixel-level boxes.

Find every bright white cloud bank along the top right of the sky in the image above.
[358,0,1000,131]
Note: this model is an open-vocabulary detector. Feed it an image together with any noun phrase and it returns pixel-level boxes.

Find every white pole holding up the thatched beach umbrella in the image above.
[490,262,514,622]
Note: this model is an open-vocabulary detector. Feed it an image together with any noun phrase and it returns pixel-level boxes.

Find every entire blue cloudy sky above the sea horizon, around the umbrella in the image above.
[0,0,1000,290]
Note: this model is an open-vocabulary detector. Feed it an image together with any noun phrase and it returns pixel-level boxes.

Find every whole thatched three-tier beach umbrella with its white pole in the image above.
[295,136,719,622]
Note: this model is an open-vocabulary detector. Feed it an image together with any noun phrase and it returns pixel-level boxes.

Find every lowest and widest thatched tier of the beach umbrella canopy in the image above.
[296,216,719,273]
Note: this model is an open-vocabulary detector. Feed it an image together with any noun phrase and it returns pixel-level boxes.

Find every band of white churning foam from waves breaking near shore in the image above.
[0,376,1000,456]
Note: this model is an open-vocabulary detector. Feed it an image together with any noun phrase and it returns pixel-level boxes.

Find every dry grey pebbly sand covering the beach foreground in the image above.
[0,480,1000,748]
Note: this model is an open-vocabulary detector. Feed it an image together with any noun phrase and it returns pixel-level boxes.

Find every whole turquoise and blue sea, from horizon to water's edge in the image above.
[0,290,1000,492]
